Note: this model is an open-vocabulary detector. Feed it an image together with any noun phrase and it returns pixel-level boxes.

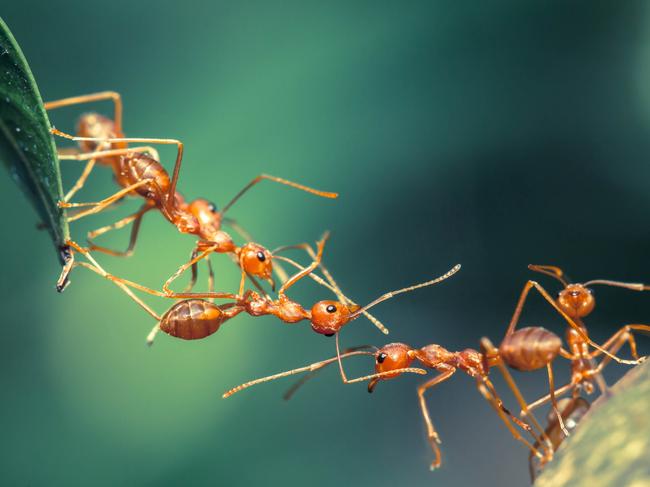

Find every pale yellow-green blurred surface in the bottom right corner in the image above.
[535,362,650,487]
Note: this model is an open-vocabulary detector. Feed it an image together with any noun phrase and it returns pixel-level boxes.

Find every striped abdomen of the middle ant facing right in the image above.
[160,299,232,340]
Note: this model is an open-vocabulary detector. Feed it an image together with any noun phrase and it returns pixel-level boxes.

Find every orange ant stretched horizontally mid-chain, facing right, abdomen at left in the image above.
[69,234,460,344]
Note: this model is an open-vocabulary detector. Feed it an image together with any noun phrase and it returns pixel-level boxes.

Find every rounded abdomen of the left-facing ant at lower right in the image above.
[499,326,562,371]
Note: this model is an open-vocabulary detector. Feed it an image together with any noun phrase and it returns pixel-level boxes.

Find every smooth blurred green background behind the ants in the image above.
[0,0,650,486]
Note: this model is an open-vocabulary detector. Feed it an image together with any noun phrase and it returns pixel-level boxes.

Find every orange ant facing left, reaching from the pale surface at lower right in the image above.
[223,327,560,470]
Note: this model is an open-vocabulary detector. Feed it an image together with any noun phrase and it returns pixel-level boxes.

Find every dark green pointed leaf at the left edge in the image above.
[0,18,70,263]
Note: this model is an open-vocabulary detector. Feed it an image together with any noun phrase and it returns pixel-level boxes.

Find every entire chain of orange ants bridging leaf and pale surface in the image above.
[45,92,650,477]
